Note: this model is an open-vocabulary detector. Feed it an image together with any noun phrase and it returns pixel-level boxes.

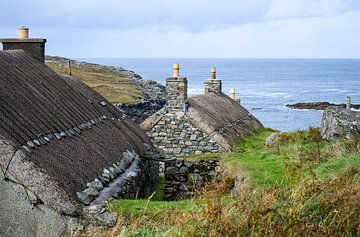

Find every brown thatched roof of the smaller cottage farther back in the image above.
[188,92,262,151]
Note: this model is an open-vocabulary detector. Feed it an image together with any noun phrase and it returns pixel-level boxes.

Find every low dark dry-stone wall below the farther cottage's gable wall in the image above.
[165,158,220,200]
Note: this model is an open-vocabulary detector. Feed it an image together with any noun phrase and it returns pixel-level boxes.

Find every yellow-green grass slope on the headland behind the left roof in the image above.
[47,63,143,103]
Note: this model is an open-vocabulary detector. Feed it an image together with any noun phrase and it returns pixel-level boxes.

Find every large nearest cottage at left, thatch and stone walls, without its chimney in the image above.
[0,28,159,236]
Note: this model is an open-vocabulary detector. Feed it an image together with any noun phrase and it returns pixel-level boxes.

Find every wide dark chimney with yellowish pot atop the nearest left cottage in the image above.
[0,26,46,63]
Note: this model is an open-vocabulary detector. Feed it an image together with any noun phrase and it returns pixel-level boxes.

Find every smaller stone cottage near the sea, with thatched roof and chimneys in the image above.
[140,64,262,155]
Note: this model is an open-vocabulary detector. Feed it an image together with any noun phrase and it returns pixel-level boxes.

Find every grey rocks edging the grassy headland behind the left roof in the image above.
[46,56,166,123]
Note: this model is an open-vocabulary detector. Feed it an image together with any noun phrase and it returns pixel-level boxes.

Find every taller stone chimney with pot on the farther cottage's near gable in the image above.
[166,63,188,112]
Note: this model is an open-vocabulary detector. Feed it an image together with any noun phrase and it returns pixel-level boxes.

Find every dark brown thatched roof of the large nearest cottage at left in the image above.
[0,50,150,214]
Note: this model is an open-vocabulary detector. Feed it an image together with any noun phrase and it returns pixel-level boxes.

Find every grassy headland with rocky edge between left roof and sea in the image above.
[46,56,165,123]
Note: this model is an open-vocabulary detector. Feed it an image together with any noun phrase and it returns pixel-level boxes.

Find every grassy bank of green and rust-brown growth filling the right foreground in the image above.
[92,128,360,236]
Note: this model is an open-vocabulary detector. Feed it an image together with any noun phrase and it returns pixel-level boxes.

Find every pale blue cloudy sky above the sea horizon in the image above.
[0,0,360,58]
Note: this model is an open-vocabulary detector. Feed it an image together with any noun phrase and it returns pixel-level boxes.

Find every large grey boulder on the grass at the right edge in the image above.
[320,106,360,141]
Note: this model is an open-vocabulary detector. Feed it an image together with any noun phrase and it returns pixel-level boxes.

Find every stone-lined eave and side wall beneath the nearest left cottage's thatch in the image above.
[76,151,159,205]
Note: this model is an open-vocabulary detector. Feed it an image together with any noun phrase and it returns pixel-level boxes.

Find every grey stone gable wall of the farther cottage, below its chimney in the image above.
[147,113,222,155]
